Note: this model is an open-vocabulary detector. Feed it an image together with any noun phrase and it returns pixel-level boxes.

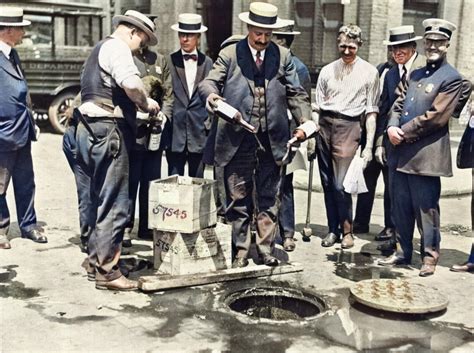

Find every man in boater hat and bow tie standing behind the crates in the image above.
[166,13,212,178]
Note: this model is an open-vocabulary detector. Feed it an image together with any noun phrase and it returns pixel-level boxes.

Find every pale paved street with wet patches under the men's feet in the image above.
[0,133,474,353]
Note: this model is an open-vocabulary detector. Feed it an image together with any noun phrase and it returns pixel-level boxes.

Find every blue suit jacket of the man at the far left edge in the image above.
[0,49,35,151]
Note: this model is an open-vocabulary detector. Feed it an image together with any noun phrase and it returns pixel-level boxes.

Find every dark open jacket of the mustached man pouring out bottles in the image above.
[199,38,311,167]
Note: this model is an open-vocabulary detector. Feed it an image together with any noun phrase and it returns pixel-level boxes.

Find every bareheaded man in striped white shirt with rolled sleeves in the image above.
[315,24,379,249]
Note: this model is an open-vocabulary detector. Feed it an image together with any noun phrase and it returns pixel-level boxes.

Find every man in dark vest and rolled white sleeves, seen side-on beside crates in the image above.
[74,10,160,290]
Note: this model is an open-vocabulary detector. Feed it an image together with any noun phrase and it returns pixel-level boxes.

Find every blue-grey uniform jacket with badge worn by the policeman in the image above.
[388,60,462,176]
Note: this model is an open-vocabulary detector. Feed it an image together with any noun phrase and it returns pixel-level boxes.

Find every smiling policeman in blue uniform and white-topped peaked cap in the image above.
[386,19,463,277]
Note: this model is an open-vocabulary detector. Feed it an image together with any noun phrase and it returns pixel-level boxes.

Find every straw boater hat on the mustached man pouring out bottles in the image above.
[239,2,287,29]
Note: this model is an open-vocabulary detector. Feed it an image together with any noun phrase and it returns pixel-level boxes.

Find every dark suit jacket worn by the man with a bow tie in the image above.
[171,50,212,153]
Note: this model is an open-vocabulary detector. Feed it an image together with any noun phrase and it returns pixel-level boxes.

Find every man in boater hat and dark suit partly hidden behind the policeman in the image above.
[353,26,426,250]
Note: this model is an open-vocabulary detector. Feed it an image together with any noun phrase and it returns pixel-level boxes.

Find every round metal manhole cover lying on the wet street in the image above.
[351,279,448,314]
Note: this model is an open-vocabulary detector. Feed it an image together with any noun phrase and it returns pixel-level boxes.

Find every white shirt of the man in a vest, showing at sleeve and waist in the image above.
[79,36,140,118]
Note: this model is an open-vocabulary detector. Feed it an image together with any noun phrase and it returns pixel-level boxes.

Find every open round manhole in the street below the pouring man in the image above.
[225,287,326,321]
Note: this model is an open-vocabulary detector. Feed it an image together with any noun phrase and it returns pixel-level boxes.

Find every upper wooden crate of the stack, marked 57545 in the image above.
[148,175,217,233]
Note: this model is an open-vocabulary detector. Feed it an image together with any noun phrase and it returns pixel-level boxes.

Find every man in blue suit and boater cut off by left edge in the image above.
[0,6,48,249]
